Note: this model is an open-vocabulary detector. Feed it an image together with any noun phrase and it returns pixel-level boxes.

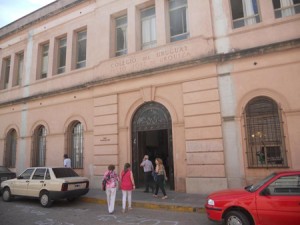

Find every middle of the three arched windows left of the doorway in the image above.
[31,125,47,166]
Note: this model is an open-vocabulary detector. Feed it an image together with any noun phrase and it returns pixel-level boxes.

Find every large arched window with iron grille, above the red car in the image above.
[245,97,287,167]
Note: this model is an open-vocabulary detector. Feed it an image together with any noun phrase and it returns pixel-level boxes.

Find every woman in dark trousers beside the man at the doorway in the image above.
[153,158,168,199]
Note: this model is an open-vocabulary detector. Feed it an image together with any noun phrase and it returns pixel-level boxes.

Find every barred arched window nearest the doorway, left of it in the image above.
[67,121,83,169]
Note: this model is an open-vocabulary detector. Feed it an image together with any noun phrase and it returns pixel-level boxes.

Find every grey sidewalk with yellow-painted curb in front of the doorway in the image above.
[81,189,206,213]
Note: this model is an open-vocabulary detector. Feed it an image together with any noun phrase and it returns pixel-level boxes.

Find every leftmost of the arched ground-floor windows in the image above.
[4,129,17,168]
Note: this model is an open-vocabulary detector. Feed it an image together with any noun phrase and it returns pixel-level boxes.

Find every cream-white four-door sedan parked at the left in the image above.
[1,167,89,207]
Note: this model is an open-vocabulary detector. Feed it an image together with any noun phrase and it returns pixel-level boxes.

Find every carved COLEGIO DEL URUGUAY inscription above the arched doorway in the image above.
[110,45,191,74]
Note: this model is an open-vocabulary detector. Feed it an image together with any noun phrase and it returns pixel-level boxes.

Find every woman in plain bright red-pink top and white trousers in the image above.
[120,163,135,213]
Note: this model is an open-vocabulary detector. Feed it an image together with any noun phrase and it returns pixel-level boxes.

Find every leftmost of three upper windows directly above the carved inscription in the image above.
[116,16,127,56]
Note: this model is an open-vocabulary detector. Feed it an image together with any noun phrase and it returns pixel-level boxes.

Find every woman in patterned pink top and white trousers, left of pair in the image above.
[103,165,119,214]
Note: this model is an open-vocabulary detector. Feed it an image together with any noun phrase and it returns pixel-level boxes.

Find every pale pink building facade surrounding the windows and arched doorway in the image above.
[0,0,300,193]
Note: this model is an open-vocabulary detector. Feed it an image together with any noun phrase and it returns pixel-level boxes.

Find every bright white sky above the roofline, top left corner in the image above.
[0,0,55,28]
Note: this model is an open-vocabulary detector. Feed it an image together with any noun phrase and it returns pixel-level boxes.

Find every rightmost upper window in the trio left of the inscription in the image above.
[76,30,87,69]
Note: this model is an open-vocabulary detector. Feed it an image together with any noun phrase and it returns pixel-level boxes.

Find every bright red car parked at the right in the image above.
[205,171,300,225]
